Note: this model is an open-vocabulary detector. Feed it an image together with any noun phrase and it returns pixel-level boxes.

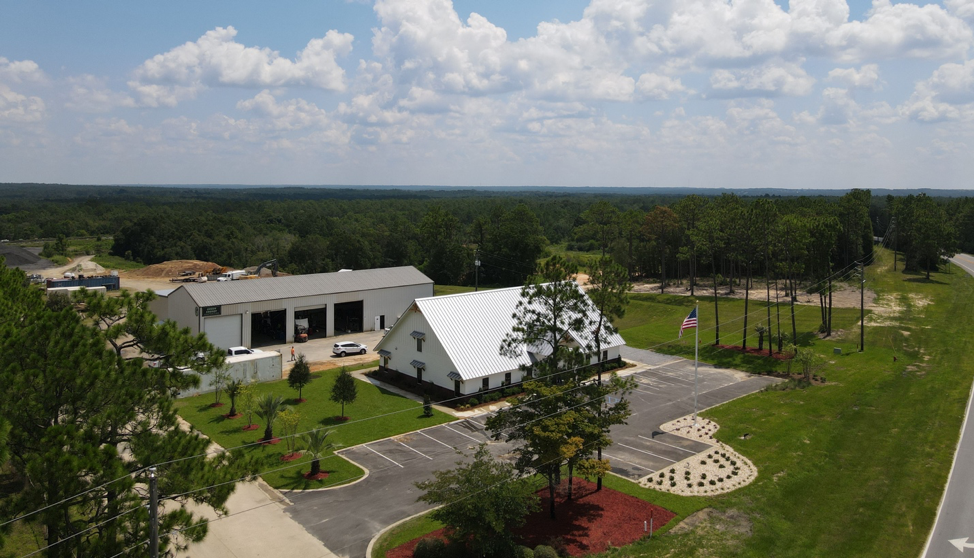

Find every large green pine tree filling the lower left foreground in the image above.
[0,262,255,557]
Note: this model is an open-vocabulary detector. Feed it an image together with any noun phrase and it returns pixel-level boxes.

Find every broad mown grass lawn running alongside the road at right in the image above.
[607,251,974,557]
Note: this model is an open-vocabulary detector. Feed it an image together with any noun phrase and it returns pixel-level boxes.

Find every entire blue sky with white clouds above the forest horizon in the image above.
[0,0,974,189]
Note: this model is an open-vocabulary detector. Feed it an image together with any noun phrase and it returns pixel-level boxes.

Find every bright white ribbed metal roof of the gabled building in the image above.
[376,287,626,380]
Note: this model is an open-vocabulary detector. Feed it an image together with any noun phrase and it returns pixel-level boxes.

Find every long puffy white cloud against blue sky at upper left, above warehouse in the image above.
[129,27,353,107]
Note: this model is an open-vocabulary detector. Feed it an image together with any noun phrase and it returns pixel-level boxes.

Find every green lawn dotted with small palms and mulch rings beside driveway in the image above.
[176,369,452,490]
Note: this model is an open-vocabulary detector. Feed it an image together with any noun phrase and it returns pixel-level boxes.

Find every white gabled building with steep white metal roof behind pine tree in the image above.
[375,287,625,395]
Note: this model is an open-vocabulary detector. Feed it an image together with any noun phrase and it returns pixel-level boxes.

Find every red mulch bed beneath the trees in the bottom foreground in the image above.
[386,478,676,558]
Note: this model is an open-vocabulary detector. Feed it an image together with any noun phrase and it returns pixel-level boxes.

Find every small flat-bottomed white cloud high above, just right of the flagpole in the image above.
[710,62,815,97]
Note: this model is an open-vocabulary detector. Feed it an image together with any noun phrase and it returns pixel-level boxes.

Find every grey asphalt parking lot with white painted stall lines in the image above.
[286,349,776,558]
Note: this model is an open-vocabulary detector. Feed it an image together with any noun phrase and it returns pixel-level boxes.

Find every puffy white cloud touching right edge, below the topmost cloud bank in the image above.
[900,60,974,122]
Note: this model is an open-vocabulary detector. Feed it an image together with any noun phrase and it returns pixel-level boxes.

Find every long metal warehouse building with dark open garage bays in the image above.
[153,266,433,348]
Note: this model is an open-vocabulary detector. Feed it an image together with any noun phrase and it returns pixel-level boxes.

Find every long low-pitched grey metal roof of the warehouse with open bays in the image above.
[177,266,433,307]
